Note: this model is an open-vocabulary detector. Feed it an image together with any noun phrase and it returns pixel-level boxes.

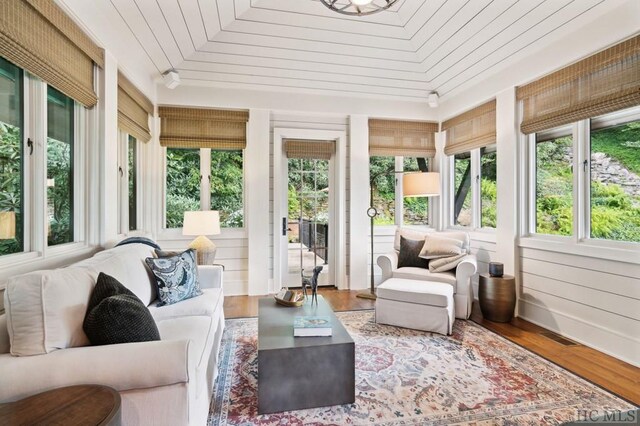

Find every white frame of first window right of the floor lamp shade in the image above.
[445,146,499,236]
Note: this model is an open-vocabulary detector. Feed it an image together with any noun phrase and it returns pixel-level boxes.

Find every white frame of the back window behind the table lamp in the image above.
[161,147,247,233]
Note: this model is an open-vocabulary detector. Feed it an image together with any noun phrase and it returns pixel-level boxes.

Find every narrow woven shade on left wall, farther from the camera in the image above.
[118,73,153,142]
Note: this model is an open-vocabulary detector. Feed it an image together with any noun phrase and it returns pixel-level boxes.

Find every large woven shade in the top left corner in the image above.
[0,0,104,108]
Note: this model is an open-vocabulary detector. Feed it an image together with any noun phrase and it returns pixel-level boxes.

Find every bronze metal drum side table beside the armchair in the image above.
[478,274,516,322]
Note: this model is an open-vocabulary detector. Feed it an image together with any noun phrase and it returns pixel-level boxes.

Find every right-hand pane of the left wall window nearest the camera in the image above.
[47,87,74,246]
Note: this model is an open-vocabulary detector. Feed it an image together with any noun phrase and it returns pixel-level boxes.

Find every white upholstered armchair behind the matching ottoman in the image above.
[377,228,478,319]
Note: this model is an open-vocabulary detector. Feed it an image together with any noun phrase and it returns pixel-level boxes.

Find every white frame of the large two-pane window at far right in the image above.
[520,106,640,256]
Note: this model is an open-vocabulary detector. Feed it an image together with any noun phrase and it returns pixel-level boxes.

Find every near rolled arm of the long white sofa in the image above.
[0,340,198,402]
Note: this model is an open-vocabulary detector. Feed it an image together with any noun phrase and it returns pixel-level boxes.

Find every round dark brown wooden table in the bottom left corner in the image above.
[0,385,121,426]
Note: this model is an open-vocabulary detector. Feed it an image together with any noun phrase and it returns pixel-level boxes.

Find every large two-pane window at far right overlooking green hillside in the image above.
[529,107,640,243]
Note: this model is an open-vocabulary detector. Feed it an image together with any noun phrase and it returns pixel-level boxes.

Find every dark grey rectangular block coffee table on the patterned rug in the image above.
[258,296,355,414]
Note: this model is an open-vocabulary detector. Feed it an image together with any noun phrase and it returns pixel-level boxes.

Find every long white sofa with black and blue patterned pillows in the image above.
[0,244,224,425]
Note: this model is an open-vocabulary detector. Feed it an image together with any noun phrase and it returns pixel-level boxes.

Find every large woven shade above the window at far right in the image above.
[517,36,640,134]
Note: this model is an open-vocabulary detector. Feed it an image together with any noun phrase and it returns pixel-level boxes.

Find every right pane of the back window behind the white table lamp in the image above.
[209,150,244,228]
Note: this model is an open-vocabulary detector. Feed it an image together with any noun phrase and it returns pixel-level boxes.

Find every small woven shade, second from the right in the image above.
[442,99,496,155]
